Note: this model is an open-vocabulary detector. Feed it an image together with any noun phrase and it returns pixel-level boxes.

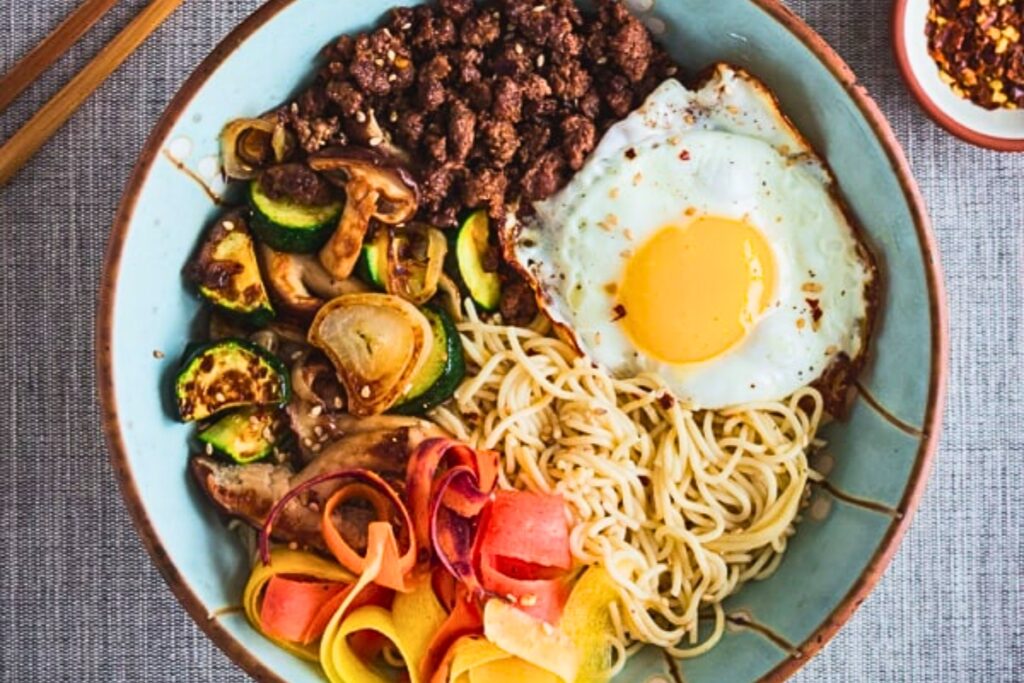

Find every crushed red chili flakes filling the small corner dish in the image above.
[925,0,1024,110]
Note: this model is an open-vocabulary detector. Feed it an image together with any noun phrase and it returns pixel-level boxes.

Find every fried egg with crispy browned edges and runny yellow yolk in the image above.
[503,65,874,409]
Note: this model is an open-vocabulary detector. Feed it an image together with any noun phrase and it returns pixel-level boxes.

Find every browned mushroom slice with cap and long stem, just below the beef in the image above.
[308,147,418,280]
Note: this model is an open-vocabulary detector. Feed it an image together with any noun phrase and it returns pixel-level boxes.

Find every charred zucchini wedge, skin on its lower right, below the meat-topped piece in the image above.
[186,213,274,327]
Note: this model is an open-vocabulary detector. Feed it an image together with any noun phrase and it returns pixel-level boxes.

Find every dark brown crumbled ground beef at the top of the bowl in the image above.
[272,0,677,322]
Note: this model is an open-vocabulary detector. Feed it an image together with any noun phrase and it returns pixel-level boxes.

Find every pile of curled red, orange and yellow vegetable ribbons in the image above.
[245,439,585,683]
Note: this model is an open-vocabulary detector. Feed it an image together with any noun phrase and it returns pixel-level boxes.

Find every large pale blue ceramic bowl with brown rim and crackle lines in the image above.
[97,0,946,683]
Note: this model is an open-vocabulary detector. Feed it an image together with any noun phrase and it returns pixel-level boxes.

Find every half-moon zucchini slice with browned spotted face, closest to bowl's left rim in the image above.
[174,339,291,422]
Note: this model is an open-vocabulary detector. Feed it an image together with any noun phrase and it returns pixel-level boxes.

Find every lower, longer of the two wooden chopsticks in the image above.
[0,0,184,186]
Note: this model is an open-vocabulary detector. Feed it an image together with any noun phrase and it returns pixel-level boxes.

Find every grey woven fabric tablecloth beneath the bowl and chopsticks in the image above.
[0,0,1024,683]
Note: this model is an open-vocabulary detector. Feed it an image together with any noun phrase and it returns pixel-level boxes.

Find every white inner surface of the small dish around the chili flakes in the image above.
[897,0,1024,142]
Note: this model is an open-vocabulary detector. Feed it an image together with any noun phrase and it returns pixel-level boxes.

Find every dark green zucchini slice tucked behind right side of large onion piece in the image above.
[391,306,466,415]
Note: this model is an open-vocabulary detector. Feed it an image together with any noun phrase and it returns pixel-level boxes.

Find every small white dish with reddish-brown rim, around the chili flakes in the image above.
[892,0,1024,152]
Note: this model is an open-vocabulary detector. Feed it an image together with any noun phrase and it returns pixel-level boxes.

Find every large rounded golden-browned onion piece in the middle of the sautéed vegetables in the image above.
[309,294,433,416]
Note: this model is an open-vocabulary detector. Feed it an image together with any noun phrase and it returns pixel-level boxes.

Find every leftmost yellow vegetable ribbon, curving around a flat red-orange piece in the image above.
[242,548,355,661]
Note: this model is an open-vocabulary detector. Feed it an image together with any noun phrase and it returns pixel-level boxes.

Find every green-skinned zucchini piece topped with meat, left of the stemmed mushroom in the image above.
[249,178,342,254]
